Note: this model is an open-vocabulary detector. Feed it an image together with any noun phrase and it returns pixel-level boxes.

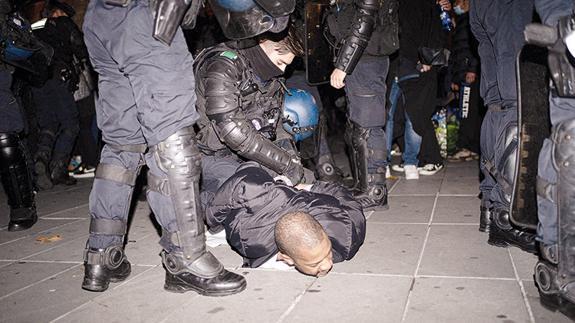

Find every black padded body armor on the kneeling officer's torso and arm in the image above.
[195,45,303,184]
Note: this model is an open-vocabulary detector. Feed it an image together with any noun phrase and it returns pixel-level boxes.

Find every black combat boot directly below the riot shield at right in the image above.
[487,209,537,254]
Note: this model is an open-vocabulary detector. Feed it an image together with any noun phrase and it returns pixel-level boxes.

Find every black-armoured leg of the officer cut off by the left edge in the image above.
[0,71,38,231]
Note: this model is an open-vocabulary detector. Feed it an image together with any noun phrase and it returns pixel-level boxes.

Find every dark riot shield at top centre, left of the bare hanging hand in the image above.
[304,0,333,85]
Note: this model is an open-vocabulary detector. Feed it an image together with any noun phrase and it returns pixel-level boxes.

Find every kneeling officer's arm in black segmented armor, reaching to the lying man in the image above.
[201,56,303,185]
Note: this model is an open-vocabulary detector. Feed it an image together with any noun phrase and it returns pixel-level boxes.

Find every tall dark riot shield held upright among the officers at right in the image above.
[509,45,551,229]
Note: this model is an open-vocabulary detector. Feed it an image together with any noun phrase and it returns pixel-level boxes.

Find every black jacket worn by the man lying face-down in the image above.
[206,162,365,267]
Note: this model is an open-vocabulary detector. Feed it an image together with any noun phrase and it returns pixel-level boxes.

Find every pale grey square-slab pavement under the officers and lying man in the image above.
[0,162,569,323]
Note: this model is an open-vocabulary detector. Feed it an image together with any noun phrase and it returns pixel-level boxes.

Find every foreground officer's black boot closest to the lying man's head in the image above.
[162,251,247,296]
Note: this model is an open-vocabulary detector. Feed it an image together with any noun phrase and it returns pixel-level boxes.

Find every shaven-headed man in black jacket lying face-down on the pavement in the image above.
[206,162,365,277]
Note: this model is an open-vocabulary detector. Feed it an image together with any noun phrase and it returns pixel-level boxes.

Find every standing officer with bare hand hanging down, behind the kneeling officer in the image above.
[327,0,399,208]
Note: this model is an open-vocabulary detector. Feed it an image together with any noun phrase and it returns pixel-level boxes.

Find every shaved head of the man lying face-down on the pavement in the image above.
[275,212,333,276]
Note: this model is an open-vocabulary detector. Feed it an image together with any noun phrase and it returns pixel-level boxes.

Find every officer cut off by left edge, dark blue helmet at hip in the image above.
[0,1,52,231]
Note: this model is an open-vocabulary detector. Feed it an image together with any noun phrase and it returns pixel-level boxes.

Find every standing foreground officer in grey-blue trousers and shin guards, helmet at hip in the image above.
[82,0,294,296]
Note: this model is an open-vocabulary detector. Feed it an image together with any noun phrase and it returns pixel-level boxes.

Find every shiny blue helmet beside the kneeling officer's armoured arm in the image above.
[283,88,319,142]
